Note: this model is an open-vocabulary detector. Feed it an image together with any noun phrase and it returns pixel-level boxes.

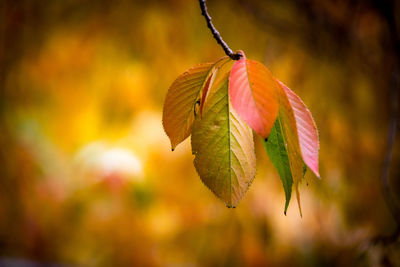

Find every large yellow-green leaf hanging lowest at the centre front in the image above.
[192,64,256,207]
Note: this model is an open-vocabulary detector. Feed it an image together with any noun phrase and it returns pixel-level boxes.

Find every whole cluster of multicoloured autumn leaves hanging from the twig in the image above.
[163,51,319,214]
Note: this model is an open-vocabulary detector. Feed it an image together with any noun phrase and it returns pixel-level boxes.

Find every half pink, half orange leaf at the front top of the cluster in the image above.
[229,52,279,138]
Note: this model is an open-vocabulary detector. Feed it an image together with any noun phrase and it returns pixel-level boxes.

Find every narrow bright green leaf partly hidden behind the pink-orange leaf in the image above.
[263,117,293,215]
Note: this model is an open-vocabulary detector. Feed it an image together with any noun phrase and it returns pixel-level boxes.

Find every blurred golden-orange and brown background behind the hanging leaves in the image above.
[0,0,400,266]
